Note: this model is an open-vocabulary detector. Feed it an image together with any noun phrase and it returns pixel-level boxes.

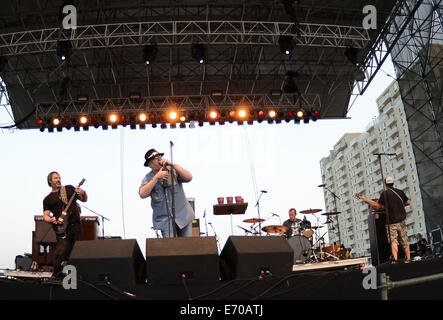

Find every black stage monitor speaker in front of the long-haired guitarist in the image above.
[68,239,146,287]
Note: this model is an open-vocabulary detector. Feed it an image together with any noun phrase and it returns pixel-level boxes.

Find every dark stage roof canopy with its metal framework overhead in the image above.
[0,0,402,128]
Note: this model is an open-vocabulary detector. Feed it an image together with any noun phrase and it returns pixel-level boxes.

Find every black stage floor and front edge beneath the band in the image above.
[0,256,443,306]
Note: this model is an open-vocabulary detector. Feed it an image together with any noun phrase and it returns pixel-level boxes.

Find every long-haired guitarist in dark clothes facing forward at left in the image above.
[43,171,88,277]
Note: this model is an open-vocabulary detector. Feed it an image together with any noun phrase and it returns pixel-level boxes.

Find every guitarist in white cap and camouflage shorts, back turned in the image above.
[358,177,411,261]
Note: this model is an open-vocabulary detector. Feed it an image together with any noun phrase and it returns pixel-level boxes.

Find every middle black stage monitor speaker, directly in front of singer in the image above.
[146,237,220,285]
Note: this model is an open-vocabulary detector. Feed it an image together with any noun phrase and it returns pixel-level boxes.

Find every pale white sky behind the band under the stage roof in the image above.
[0,59,395,269]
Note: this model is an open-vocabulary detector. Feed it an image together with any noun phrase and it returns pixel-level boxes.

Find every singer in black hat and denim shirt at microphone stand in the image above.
[138,149,195,238]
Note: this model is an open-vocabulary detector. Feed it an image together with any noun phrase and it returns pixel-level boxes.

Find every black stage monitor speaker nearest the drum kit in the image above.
[220,236,294,280]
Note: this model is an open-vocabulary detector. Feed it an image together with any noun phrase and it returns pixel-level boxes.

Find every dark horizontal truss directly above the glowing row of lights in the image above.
[36,94,320,119]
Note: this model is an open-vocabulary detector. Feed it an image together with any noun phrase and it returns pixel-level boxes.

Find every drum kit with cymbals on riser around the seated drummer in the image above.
[238,209,350,264]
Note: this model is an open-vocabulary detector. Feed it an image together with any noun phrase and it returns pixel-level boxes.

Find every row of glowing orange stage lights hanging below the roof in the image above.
[37,108,320,132]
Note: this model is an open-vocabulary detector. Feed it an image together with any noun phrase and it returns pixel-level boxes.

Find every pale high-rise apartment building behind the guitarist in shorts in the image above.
[320,81,426,257]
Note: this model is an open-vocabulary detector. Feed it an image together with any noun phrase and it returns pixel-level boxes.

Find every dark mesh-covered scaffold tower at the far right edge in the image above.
[387,0,443,231]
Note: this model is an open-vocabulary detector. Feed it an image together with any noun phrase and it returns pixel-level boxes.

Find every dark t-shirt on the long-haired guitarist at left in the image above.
[43,185,80,225]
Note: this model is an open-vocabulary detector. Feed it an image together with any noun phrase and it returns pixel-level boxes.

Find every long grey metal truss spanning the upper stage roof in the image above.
[0,21,370,55]
